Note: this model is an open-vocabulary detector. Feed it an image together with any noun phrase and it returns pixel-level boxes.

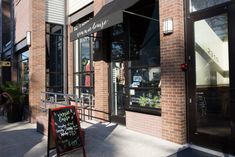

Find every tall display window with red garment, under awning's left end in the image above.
[74,37,94,98]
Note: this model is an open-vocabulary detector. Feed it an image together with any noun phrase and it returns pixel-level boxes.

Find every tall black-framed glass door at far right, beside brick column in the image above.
[187,2,235,154]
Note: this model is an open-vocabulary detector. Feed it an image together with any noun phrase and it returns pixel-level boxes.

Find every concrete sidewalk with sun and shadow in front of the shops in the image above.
[0,117,182,157]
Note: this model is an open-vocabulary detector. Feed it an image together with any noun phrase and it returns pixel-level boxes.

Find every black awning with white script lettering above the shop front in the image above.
[70,0,139,41]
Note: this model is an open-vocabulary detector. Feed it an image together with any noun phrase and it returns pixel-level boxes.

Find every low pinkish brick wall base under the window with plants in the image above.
[126,111,162,138]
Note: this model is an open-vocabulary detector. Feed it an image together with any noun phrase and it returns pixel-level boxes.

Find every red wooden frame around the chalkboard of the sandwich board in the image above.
[47,106,86,157]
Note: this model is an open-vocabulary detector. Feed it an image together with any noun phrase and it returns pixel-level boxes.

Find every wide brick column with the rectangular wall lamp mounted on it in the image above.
[159,0,186,144]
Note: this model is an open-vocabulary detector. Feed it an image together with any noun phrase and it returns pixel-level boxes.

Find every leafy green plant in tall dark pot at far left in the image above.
[1,82,25,123]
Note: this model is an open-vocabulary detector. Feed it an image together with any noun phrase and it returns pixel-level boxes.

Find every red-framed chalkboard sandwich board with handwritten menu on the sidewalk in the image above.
[48,106,86,157]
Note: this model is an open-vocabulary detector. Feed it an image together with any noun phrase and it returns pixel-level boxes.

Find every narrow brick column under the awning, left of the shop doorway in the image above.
[94,0,109,121]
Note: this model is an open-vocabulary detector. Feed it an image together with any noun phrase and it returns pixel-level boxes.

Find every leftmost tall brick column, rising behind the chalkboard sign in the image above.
[29,0,46,122]
